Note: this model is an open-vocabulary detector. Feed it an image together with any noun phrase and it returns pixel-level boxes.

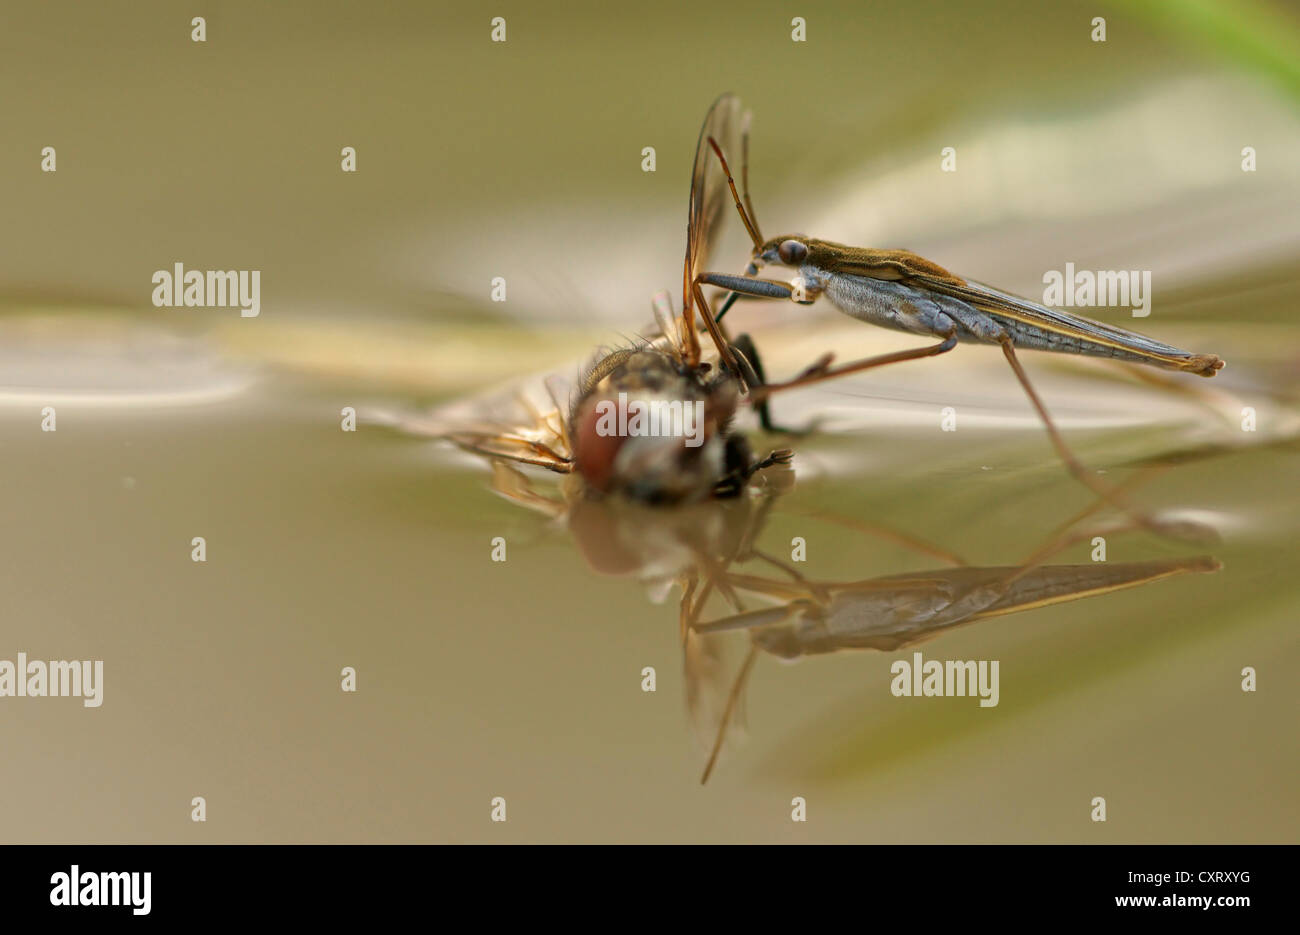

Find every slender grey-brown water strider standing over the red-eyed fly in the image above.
[697,99,1223,525]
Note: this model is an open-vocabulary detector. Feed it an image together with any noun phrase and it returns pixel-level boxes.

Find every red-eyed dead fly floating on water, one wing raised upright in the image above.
[426,96,792,503]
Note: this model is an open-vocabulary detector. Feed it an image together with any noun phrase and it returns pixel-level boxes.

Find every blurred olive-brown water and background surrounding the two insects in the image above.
[0,0,1300,843]
